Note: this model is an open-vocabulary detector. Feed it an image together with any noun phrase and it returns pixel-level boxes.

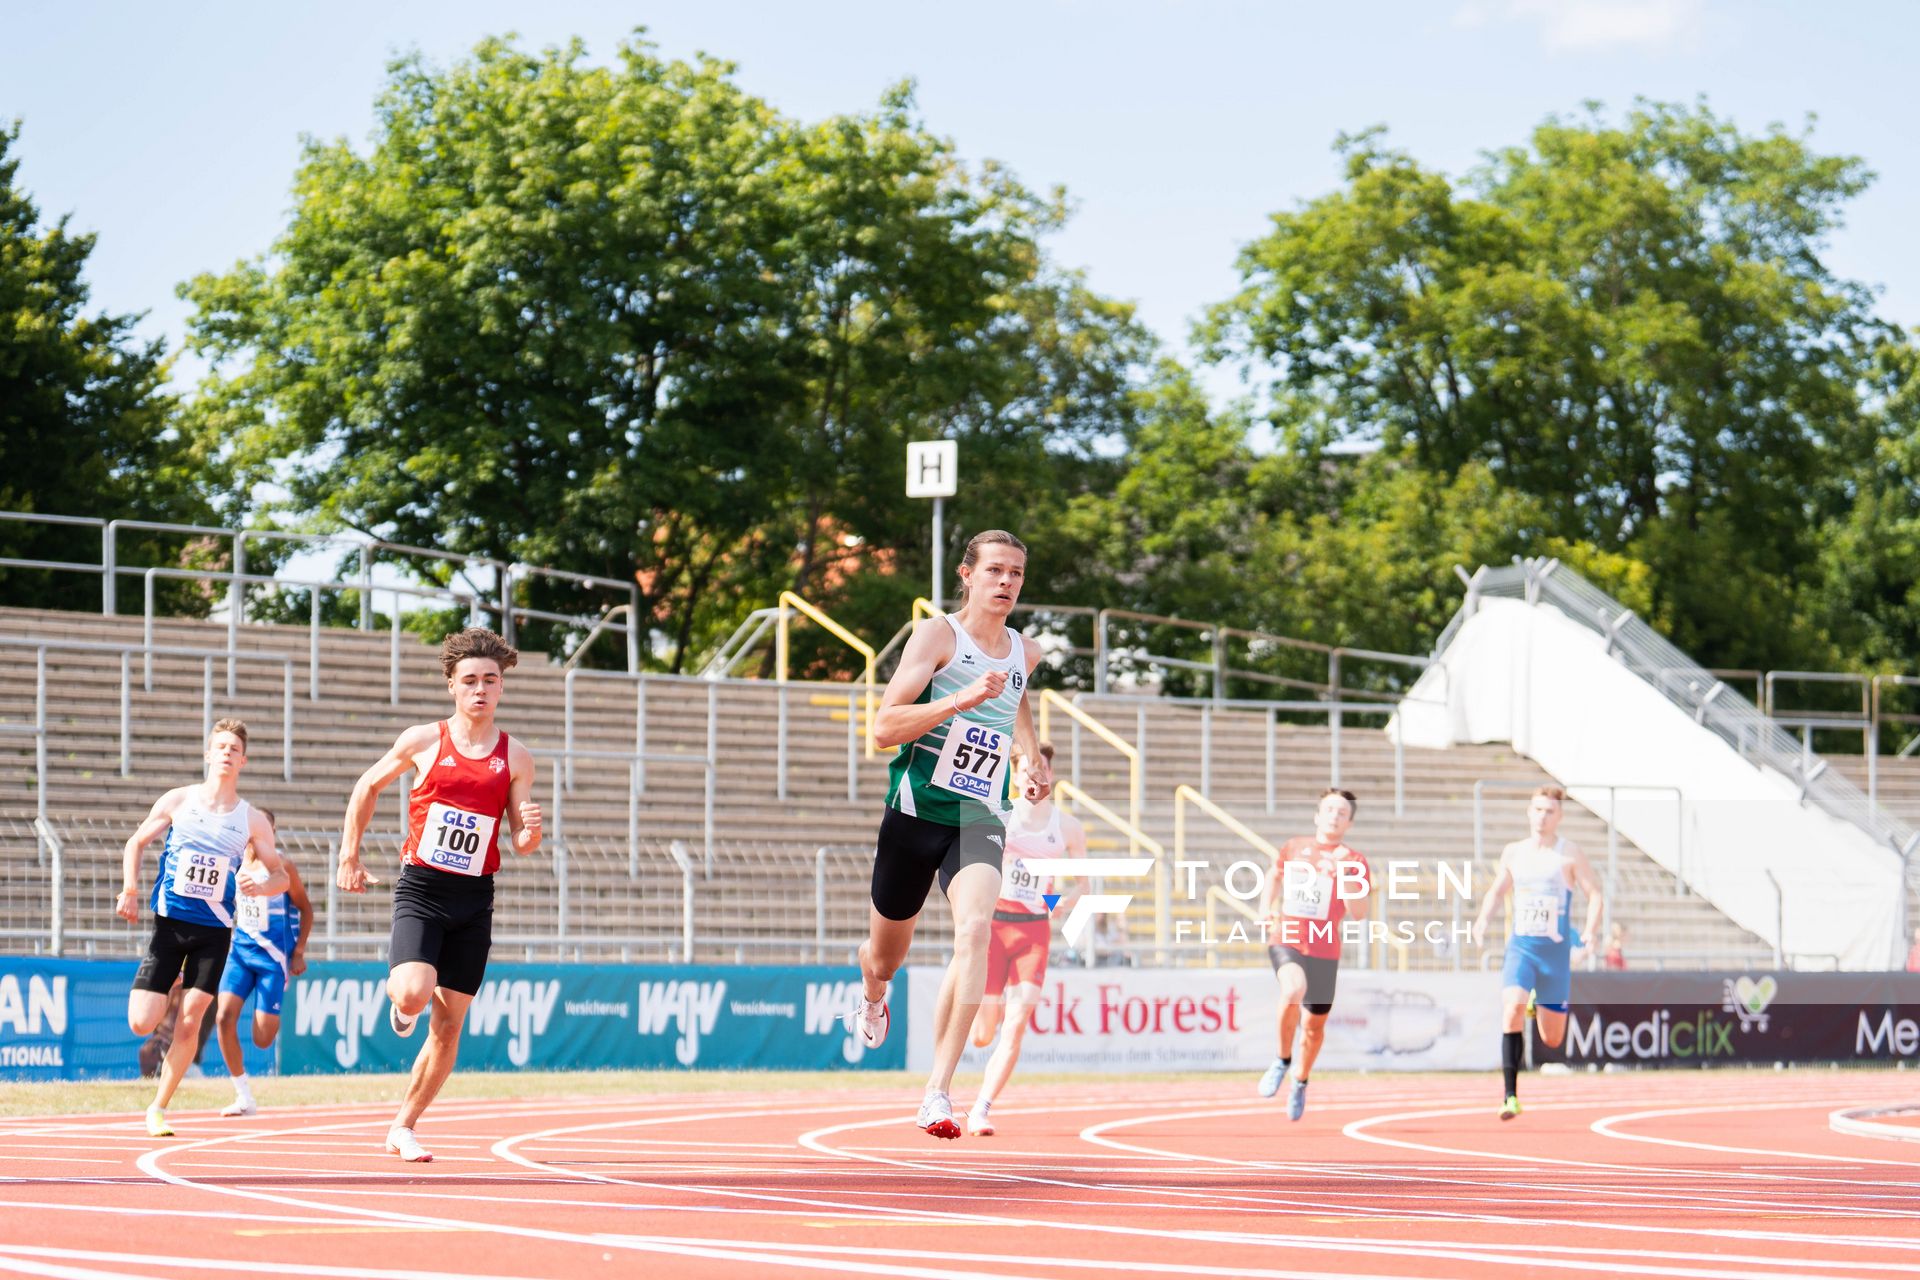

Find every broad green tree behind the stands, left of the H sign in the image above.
[186,38,1144,666]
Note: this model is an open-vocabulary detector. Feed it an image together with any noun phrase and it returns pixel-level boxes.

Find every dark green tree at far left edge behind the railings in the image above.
[0,123,219,610]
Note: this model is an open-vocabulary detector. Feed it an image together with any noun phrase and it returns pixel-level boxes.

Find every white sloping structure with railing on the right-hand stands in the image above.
[1396,560,1920,969]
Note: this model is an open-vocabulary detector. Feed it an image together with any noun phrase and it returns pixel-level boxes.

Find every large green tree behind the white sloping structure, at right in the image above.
[1204,104,1889,666]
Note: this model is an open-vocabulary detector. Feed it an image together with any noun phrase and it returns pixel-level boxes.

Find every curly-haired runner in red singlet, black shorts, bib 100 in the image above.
[338,628,540,1161]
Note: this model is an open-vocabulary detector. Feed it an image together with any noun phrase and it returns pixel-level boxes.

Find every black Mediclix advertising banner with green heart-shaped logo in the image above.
[1534,971,1920,1067]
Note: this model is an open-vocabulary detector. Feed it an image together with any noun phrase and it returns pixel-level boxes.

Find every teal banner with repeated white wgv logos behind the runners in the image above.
[280,963,908,1075]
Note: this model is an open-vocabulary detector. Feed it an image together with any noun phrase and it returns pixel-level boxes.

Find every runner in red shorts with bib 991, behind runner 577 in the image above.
[966,743,1087,1138]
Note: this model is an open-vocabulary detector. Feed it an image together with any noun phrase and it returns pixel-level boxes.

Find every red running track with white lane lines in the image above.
[0,1071,1920,1280]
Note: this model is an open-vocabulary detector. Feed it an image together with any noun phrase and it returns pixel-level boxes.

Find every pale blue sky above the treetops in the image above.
[0,0,1920,387]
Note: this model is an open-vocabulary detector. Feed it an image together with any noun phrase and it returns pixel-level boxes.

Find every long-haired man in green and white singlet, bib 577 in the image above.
[852,530,1052,1138]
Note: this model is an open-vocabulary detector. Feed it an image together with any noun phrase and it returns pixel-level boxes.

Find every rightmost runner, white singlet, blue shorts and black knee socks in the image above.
[1473,787,1607,1121]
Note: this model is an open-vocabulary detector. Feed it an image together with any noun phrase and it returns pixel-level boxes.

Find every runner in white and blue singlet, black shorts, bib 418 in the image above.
[113,720,286,1138]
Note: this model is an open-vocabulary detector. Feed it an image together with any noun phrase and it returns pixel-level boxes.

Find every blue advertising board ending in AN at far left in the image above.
[0,956,273,1080]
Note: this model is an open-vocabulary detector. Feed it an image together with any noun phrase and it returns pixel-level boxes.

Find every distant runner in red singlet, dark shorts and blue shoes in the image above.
[1260,787,1373,1121]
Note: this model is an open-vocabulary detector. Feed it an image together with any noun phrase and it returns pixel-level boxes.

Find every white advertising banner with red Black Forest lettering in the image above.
[908,965,1500,1073]
